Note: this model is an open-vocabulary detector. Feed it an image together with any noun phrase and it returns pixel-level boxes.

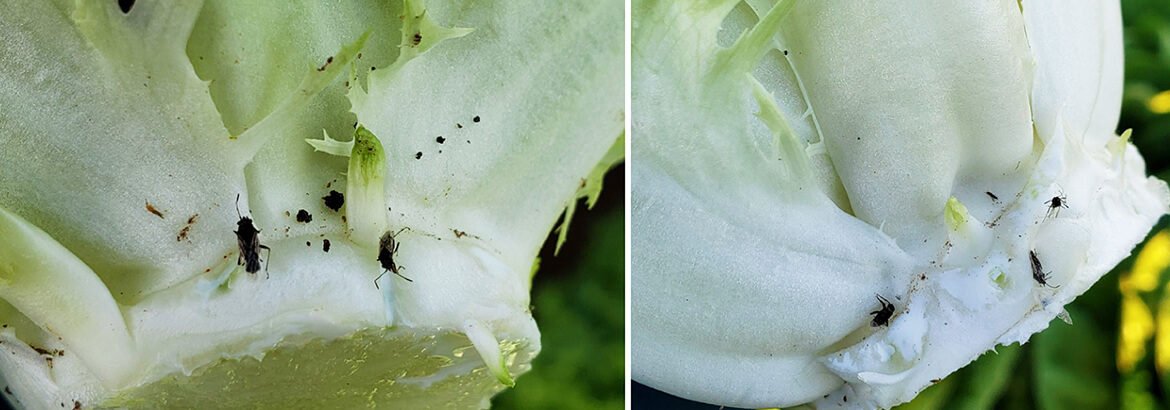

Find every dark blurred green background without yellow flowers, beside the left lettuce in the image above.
[491,165,626,409]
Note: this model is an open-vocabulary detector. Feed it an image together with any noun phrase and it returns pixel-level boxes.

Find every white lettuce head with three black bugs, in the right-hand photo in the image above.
[631,0,1170,408]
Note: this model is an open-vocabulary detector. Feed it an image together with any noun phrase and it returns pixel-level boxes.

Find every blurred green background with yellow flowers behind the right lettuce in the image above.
[633,0,1170,410]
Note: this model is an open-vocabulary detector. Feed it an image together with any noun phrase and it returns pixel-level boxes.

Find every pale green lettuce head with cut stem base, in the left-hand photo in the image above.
[0,0,624,409]
